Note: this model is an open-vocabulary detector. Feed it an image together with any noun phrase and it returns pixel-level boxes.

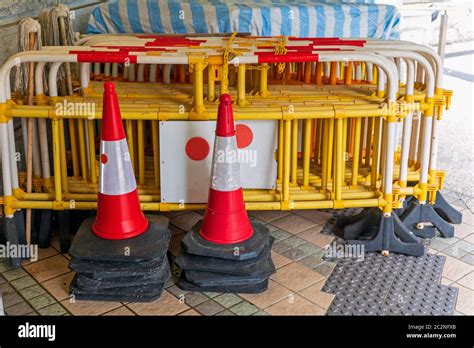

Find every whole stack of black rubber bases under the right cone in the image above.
[175,222,275,293]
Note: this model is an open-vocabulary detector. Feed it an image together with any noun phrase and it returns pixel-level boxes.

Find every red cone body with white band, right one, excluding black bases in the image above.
[199,94,253,244]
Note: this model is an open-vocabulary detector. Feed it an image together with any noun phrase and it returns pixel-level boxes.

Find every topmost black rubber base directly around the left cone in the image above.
[69,215,171,261]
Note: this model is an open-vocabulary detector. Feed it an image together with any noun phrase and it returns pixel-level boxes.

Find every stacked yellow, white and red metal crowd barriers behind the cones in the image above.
[0,34,461,255]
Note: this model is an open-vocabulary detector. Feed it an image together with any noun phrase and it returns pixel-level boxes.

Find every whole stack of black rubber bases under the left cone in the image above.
[69,215,171,302]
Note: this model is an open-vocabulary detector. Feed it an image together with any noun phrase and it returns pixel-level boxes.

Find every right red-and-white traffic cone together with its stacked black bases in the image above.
[175,94,275,294]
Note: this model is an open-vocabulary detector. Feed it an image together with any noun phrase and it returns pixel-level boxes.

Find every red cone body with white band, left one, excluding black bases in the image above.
[92,82,148,239]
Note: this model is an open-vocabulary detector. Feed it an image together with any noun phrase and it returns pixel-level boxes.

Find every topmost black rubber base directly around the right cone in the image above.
[181,221,270,260]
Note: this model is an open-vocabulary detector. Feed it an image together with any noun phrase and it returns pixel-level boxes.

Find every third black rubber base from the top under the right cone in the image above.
[183,268,275,286]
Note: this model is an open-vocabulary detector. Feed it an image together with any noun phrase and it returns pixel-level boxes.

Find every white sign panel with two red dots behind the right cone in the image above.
[160,120,278,203]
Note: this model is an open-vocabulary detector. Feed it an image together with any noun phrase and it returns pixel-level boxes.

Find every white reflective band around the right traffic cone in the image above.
[211,136,242,191]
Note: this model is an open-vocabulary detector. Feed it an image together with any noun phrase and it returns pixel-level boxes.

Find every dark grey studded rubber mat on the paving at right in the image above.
[321,209,457,315]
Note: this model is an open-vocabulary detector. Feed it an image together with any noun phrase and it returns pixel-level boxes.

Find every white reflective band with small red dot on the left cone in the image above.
[99,139,137,195]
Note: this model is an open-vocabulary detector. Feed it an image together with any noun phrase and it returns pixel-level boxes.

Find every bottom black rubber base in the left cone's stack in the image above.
[69,276,165,302]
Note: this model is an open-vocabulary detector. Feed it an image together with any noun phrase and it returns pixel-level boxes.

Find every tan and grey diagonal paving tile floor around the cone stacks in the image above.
[0,191,474,315]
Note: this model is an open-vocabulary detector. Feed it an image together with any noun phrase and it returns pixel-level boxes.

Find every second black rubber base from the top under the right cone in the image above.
[174,236,274,275]
